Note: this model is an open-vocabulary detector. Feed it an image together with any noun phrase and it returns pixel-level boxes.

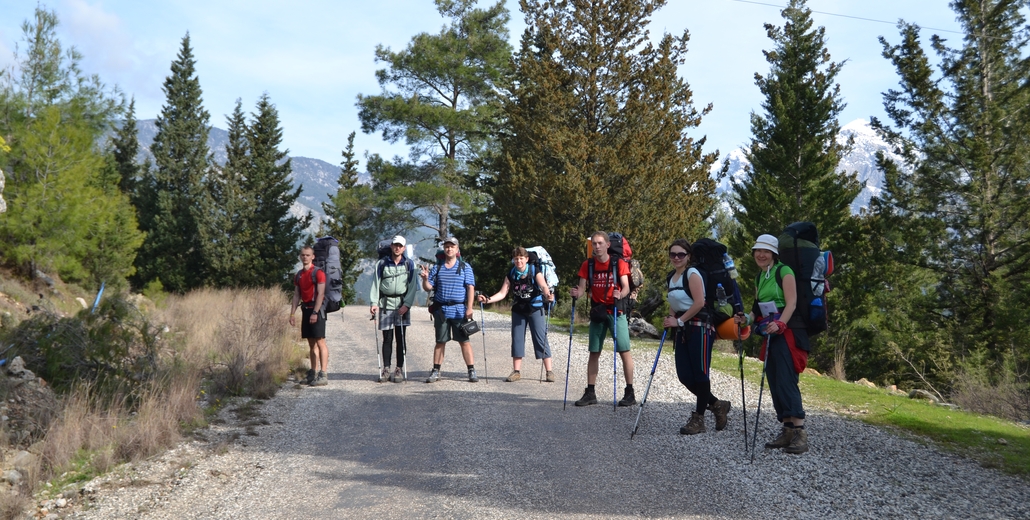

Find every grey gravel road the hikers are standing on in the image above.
[68,306,1030,520]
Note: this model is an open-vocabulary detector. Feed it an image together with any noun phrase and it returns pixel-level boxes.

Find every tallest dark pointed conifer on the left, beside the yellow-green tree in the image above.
[135,33,211,292]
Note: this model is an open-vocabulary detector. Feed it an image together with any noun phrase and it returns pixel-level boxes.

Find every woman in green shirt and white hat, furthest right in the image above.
[733,235,811,454]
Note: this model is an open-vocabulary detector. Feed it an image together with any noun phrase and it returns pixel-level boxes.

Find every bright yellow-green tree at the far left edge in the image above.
[0,8,142,286]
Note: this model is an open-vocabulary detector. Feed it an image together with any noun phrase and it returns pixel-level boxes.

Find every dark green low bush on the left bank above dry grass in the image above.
[5,297,161,402]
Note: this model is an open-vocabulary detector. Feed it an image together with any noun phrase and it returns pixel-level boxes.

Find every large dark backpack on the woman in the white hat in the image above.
[776,222,833,336]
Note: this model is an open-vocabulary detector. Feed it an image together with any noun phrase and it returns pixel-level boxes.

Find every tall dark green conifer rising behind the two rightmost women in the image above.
[729,0,861,375]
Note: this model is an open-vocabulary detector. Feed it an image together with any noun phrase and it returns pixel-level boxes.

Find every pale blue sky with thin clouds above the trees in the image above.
[0,0,961,167]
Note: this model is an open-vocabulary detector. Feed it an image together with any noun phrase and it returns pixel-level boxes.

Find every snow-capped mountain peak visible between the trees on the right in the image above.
[712,119,901,213]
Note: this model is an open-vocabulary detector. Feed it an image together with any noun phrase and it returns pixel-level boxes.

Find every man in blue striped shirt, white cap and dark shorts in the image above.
[418,237,479,383]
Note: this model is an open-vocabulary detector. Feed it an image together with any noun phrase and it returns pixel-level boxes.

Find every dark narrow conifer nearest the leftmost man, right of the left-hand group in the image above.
[244,94,311,284]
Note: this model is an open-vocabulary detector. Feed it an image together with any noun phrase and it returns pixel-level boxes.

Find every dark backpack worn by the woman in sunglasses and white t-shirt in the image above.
[690,238,744,327]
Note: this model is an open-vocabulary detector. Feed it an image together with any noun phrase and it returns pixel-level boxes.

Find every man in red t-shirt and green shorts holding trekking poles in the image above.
[570,231,637,407]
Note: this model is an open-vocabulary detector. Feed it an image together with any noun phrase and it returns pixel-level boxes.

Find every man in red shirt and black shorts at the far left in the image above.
[289,246,329,386]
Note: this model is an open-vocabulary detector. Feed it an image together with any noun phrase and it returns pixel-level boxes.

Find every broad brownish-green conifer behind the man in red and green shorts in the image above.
[492,0,716,284]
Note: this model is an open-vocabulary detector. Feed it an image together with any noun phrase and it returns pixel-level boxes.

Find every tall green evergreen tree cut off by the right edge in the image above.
[873,0,1030,380]
